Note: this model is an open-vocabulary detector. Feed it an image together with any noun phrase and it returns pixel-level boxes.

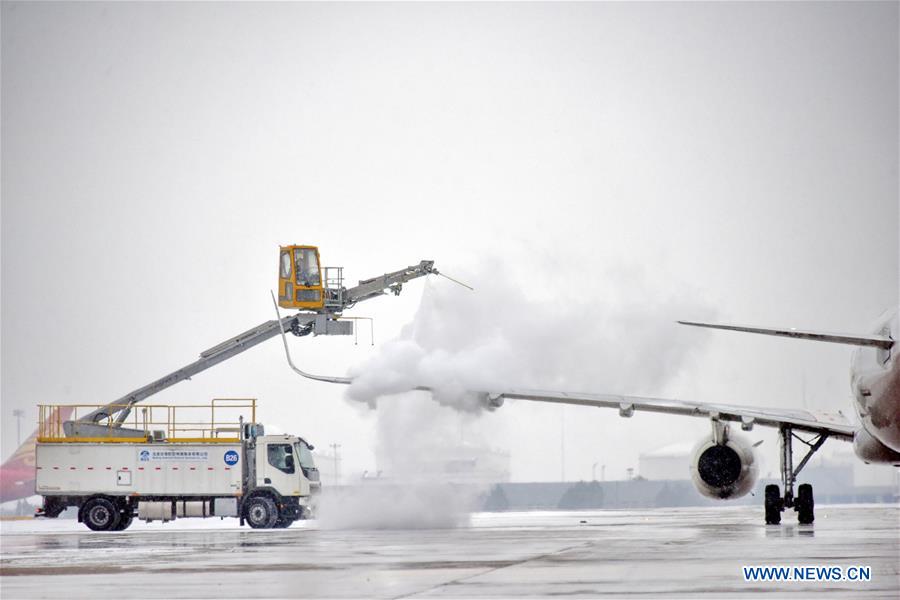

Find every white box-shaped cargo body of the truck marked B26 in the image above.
[35,442,244,496]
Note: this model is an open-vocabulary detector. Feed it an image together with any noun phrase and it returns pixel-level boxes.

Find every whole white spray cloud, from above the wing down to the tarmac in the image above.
[322,262,713,528]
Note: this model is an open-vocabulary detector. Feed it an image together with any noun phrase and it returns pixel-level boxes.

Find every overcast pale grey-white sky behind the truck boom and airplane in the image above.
[0,2,900,481]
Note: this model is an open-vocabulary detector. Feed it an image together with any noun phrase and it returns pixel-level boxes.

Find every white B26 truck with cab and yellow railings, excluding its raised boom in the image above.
[35,401,320,531]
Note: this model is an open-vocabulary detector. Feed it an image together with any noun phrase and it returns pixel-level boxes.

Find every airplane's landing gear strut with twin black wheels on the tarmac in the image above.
[766,425,828,525]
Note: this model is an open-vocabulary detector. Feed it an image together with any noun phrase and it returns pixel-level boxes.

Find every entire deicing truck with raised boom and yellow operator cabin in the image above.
[35,245,442,531]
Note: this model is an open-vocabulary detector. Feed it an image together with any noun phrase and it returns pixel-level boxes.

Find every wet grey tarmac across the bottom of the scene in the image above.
[0,505,900,600]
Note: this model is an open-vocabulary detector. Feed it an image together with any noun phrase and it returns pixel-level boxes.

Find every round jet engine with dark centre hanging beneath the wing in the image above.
[691,428,758,500]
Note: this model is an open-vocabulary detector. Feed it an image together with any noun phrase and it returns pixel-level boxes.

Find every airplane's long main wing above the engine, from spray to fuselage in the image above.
[487,390,857,441]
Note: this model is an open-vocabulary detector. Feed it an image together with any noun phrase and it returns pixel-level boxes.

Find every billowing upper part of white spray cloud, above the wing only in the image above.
[348,268,712,411]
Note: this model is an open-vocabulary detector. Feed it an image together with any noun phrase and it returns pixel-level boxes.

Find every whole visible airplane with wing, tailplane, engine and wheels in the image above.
[275,303,900,525]
